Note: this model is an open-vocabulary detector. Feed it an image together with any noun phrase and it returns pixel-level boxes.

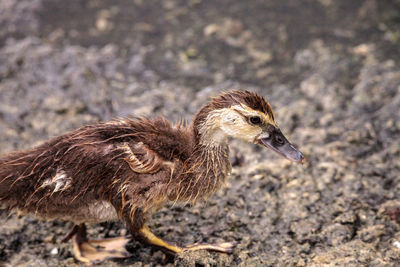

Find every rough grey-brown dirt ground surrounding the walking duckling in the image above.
[0,0,400,266]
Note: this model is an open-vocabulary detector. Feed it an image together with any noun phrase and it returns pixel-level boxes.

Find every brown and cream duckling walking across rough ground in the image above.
[0,90,305,263]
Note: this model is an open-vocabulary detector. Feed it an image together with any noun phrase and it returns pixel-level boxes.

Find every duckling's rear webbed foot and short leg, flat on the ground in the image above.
[63,224,131,263]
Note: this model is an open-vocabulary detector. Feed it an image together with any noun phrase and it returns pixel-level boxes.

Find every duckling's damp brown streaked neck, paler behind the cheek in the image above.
[169,110,231,203]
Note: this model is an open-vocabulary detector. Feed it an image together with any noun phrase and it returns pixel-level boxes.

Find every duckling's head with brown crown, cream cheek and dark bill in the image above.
[194,90,304,162]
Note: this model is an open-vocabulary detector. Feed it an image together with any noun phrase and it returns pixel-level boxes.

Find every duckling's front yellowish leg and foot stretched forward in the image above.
[136,225,235,253]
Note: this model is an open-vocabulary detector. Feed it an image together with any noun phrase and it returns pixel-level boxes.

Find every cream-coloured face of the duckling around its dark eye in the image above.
[220,105,275,143]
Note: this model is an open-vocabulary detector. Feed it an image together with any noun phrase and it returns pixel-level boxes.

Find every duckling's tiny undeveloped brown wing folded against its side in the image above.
[121,142,164,173]
